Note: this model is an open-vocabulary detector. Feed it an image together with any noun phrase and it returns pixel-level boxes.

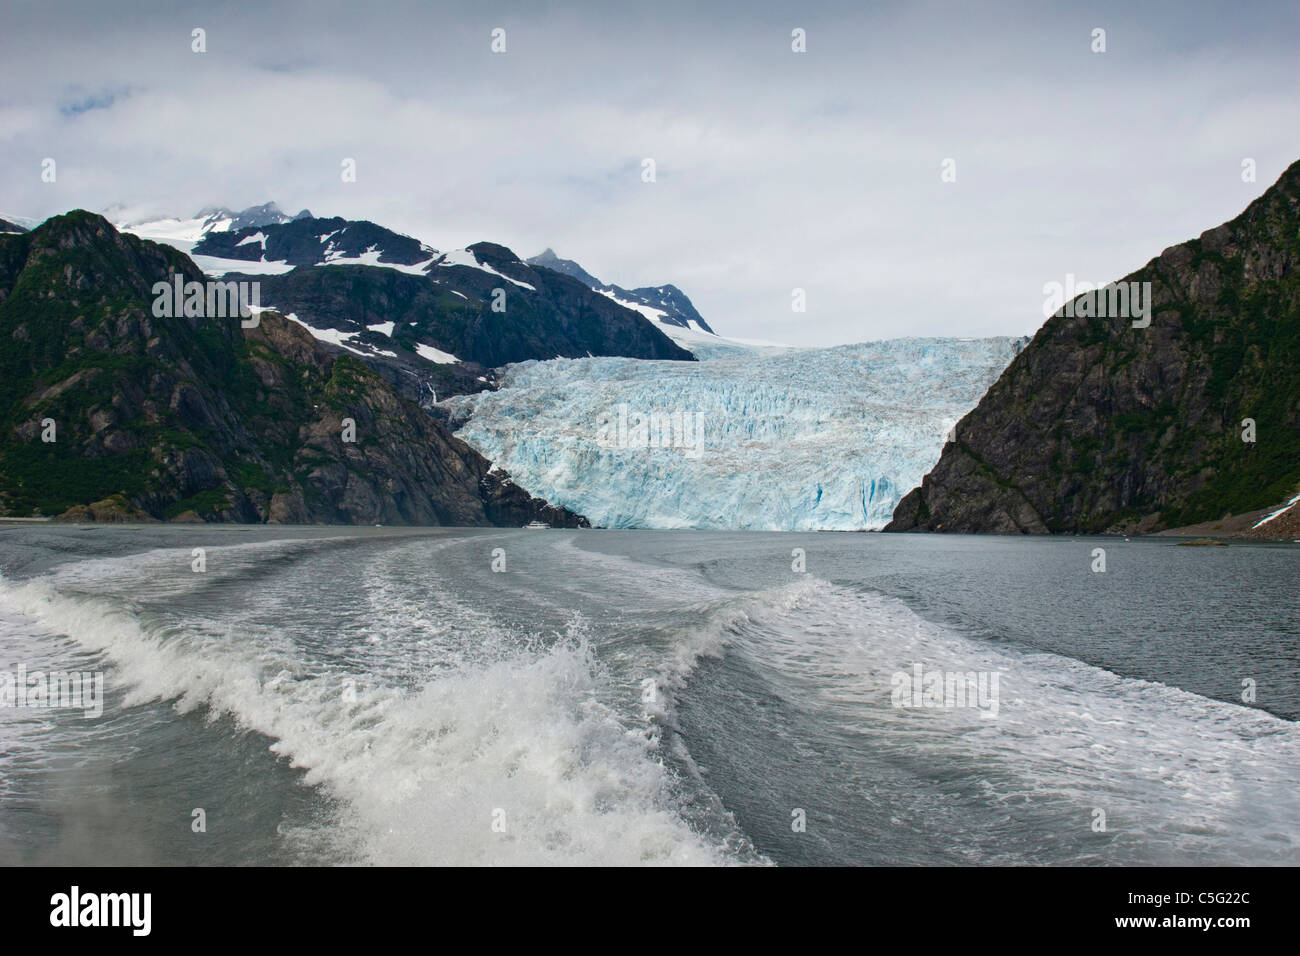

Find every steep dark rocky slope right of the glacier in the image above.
[885,163,1300,533]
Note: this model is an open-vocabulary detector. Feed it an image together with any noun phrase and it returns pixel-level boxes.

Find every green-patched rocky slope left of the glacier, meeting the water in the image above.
[0,211,582,527]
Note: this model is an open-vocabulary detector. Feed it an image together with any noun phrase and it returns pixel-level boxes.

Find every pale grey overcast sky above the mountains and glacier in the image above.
[0,0,1300,345]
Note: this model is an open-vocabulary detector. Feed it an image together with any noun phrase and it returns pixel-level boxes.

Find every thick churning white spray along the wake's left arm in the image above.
[0,564,727,865]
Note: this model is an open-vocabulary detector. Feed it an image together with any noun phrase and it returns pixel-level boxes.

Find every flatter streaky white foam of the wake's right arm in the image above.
[732,581,1300,865]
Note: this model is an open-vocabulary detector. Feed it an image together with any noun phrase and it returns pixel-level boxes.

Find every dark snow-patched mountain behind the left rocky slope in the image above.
[184,219,693,379]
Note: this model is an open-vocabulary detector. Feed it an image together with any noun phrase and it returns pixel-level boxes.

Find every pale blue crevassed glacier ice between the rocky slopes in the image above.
[443,337,1022,531]
